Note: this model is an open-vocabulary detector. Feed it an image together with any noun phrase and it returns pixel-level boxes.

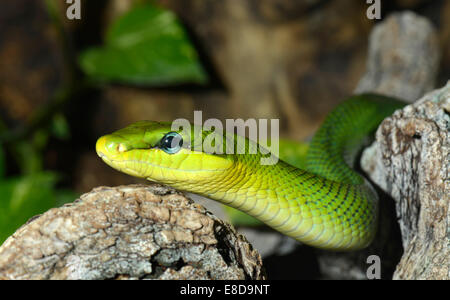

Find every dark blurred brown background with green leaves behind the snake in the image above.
[0,0,450,276]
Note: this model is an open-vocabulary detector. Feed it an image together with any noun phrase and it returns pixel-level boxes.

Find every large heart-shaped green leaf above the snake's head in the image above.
[79,4,207,86]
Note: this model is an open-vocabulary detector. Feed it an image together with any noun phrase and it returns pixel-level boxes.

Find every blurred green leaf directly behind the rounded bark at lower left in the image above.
[0,172,75,244]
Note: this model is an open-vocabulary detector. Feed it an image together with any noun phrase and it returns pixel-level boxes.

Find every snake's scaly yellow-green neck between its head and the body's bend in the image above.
[190,156,377,250]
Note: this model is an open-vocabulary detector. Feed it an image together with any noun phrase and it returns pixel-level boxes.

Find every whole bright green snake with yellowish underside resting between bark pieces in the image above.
[96,94,404,251]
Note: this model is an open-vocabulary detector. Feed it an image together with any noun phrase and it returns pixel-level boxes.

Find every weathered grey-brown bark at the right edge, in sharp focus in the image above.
[369,82,450,279]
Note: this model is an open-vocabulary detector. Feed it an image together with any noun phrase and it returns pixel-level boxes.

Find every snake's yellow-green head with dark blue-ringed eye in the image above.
[96,121,234,190]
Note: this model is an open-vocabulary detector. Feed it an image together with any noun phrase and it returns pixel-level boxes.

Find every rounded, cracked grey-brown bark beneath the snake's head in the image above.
[0,184,265,280]
